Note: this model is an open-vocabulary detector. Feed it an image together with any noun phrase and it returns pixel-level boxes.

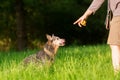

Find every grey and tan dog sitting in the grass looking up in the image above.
[24,34,65,65]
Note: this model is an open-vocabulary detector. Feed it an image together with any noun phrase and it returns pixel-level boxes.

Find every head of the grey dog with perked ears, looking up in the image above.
[46,34,65,46]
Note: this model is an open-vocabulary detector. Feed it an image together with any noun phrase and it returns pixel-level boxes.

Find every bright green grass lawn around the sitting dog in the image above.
[0,45,120,80]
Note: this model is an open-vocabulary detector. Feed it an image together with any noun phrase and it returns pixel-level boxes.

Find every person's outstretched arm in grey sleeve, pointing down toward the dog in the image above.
[73,0,104,27]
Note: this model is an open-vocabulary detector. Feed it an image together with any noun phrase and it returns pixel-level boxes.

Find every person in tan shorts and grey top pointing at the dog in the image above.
[73,0,120,73]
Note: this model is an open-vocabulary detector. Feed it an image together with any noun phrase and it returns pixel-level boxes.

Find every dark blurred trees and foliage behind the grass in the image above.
[0,0,108,50]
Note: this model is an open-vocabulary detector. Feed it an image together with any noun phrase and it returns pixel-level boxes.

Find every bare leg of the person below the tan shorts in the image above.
[110,45,120,73]
